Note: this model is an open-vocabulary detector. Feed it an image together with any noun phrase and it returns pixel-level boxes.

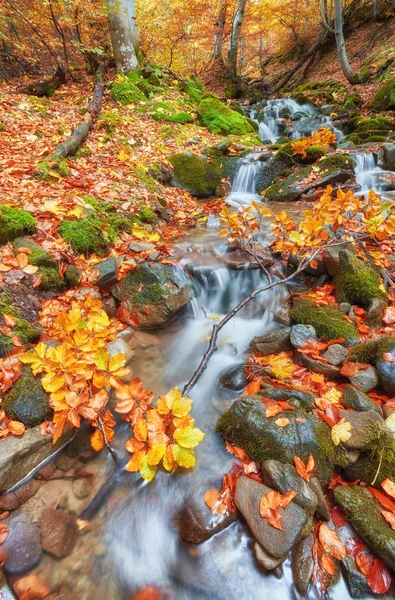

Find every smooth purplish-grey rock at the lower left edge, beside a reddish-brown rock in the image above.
[3,519,41,575]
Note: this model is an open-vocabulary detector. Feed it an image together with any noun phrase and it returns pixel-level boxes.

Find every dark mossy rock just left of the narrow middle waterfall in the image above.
[168,152,223,198]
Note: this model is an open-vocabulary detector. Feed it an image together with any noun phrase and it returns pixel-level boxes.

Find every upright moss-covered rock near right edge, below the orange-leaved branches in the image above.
[334,250,388,309]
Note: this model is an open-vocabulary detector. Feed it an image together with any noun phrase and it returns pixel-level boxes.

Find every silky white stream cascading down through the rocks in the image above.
[8,100,391,600]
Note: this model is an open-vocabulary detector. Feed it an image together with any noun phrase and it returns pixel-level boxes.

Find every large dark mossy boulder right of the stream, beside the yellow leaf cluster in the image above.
[217,396,337,481]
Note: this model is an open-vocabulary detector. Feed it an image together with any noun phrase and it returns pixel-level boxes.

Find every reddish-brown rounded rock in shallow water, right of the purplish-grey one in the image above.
[39,508,78,558]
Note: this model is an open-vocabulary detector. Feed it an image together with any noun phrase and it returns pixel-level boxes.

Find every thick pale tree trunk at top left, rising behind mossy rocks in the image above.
[107,0,140,73]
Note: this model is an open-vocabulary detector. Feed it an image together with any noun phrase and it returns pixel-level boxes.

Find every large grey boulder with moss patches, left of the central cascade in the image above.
[111,263,194,329]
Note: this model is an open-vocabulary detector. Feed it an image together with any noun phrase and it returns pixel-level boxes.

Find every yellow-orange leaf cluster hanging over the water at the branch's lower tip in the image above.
[115,379,204,481]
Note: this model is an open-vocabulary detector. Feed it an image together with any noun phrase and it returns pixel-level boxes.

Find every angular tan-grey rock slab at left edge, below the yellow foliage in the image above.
[0,427,72,492]
